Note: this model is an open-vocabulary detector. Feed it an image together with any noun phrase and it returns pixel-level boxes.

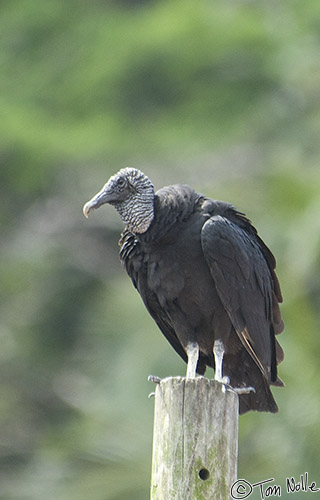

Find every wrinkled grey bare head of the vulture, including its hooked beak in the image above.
[83,168,154,233]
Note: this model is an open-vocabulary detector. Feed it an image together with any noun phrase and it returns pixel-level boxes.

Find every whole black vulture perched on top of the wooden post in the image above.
[83,168,284,413]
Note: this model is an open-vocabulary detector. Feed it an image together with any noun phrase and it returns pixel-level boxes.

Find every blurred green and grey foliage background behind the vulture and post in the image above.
[0,0,320,500]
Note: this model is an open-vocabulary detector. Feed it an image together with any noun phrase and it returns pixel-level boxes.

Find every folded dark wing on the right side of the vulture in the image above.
[201,215,279,382]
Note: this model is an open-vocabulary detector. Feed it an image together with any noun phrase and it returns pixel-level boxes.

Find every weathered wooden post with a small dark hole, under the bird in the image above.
[151,377,239,500]
